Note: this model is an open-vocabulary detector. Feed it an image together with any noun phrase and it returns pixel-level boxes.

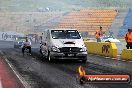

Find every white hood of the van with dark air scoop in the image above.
[52,39,85,48]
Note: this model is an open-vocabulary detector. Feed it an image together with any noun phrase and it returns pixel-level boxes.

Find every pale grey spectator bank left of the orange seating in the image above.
[0,12,62,34]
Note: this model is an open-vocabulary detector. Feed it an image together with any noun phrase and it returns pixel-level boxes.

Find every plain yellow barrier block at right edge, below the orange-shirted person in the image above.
[121,49,132,60]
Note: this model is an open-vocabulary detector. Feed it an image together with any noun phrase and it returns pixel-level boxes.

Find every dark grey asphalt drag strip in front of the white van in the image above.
[2,49,132,88]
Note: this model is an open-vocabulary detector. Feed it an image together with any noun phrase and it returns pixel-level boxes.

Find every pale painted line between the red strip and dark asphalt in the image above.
[0,50,31,88]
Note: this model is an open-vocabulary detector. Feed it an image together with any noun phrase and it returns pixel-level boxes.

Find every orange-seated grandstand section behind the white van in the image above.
[57,9,118,35]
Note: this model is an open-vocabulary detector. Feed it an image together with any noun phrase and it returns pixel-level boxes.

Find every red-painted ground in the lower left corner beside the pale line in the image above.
[0,52,24,88]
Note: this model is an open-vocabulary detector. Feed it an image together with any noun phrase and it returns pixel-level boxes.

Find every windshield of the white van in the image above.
[51,30,81,39]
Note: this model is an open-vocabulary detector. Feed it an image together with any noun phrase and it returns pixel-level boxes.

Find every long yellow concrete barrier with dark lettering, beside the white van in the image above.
[84,41,117,58]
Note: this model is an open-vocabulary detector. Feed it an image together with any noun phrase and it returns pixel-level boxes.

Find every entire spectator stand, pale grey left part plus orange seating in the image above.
[0,9,118,35]
